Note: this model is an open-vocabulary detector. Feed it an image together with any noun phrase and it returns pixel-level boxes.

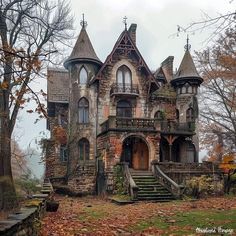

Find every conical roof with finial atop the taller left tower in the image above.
[64,14,102,68]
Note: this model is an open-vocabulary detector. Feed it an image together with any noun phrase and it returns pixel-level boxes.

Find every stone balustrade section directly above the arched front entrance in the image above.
[101,116,157,132]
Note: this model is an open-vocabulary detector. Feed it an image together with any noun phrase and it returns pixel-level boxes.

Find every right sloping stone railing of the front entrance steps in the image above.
[152,162,184,198]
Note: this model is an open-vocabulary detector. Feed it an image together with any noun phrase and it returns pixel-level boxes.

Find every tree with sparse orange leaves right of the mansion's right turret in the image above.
[197,28,236,154]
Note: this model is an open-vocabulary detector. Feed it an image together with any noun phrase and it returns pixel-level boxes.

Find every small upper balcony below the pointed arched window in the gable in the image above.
[110,83,139,97]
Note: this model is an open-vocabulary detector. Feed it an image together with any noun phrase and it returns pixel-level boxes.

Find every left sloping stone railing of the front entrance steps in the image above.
[122,162,138,200]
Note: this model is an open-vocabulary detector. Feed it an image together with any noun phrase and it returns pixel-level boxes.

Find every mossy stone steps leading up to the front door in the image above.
[130,169,175,202]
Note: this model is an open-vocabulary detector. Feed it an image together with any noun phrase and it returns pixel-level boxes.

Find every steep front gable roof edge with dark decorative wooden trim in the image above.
[91,29,159,86]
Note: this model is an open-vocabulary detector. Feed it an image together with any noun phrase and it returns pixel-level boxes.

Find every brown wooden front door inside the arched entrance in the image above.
[132,141,148,170]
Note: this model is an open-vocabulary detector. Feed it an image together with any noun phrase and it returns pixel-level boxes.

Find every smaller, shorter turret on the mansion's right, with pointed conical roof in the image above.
[171,38,203,162]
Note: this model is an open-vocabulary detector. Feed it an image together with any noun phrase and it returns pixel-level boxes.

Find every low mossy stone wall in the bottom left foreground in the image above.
[0,182,53,236]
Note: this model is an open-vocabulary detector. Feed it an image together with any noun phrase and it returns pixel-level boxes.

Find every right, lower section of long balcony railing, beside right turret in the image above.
[161,121,195,134]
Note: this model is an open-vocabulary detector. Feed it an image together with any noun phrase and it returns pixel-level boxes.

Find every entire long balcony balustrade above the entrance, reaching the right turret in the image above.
[101,116,195,135]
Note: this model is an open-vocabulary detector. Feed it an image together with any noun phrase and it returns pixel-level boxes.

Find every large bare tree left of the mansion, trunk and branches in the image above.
[0,0,72,210]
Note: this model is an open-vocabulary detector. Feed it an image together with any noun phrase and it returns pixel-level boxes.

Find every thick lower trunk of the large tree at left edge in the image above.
[0,113,18,211]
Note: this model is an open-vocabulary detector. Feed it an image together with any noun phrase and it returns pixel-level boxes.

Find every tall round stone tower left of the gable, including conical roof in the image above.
[64,17,102,194]
